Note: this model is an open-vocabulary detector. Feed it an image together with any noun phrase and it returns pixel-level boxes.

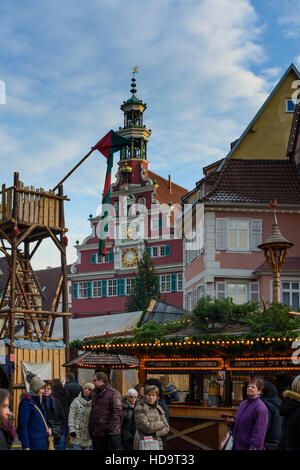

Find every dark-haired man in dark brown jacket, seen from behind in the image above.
[89,372,122,450]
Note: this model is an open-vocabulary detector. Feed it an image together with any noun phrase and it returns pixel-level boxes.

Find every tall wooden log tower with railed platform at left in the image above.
[0,172,71,388]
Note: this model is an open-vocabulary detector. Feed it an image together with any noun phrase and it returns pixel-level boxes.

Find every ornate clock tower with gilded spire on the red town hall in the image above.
[111,67,154,270]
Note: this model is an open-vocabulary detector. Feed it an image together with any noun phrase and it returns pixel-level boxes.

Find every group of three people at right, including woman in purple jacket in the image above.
[220,375,300,450]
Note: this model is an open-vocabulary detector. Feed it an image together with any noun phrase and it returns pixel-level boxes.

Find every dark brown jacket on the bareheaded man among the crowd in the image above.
[89,384,122,437]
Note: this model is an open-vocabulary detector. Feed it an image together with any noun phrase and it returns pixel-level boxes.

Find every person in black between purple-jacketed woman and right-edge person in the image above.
[261,380,282,450]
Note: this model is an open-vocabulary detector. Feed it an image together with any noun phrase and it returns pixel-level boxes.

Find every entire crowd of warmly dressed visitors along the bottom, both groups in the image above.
[0,371,300,451]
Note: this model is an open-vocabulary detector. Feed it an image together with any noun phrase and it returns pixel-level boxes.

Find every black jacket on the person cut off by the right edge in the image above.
[279,390,300,450]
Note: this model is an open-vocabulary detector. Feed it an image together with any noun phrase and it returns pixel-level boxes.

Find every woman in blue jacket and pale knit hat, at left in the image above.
[17,373,51,450]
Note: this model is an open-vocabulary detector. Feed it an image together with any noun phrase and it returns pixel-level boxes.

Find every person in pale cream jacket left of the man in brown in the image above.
[69,382,95,450]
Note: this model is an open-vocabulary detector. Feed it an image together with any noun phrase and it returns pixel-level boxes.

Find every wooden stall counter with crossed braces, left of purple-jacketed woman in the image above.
[167,402,237,450]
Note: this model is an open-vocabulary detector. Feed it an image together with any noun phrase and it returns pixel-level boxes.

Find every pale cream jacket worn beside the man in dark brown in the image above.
[69,392,92,447]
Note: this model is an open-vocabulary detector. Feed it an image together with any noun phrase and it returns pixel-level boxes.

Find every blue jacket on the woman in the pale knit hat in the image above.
[17,393,48,450]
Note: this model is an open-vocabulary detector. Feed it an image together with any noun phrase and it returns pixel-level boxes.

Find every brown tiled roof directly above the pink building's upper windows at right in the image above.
[199,159,300,205]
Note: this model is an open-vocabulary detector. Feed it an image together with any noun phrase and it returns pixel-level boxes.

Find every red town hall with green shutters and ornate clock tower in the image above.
[70,77,187,318]
